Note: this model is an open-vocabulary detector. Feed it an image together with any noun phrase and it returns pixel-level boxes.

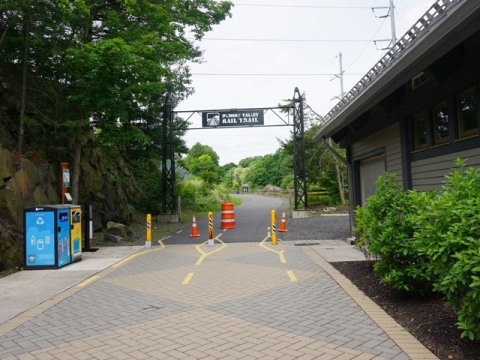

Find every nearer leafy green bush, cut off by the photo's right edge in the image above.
[415,160,480,340]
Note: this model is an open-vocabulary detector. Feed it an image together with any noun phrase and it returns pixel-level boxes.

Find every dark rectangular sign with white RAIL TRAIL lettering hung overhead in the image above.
[202,109,263,128]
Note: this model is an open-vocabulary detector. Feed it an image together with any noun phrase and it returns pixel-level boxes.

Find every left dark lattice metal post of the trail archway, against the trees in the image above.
[162,93,177,215]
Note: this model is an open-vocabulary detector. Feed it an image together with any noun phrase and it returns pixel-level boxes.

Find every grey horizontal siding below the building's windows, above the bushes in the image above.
[412,148,480,191]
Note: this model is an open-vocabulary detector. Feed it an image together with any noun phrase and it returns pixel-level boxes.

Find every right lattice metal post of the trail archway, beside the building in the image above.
[293,88,308,210]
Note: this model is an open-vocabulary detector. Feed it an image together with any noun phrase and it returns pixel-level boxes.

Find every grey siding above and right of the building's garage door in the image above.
[351,123,403,182]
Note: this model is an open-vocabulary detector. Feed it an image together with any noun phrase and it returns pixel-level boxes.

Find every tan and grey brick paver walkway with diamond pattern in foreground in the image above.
[0,243,420,360]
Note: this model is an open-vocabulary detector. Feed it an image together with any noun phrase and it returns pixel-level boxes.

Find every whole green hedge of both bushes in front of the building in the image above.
[355,160,480,340]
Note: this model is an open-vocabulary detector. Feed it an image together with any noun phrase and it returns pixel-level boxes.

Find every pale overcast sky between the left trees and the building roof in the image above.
[175,0,436,165]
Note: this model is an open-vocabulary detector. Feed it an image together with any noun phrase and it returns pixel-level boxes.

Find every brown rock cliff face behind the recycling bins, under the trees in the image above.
[0,131,141,270]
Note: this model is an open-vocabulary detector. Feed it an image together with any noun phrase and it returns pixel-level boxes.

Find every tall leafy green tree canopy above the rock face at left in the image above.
[0,0,232,207]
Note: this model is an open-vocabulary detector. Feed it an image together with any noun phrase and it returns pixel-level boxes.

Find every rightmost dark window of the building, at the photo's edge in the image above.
[457,88,478,139]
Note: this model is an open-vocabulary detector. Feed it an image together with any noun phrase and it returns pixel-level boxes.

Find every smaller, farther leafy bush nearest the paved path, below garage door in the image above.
[355,173,432,293]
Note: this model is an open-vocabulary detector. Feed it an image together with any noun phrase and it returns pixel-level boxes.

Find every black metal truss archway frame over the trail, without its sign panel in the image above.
[162,88,308,214]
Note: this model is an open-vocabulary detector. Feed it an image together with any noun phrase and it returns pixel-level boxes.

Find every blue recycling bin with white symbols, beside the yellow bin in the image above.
[23,205,72,269]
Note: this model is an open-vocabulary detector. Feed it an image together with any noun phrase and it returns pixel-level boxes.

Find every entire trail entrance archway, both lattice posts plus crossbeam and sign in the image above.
[162,88,308,215]
